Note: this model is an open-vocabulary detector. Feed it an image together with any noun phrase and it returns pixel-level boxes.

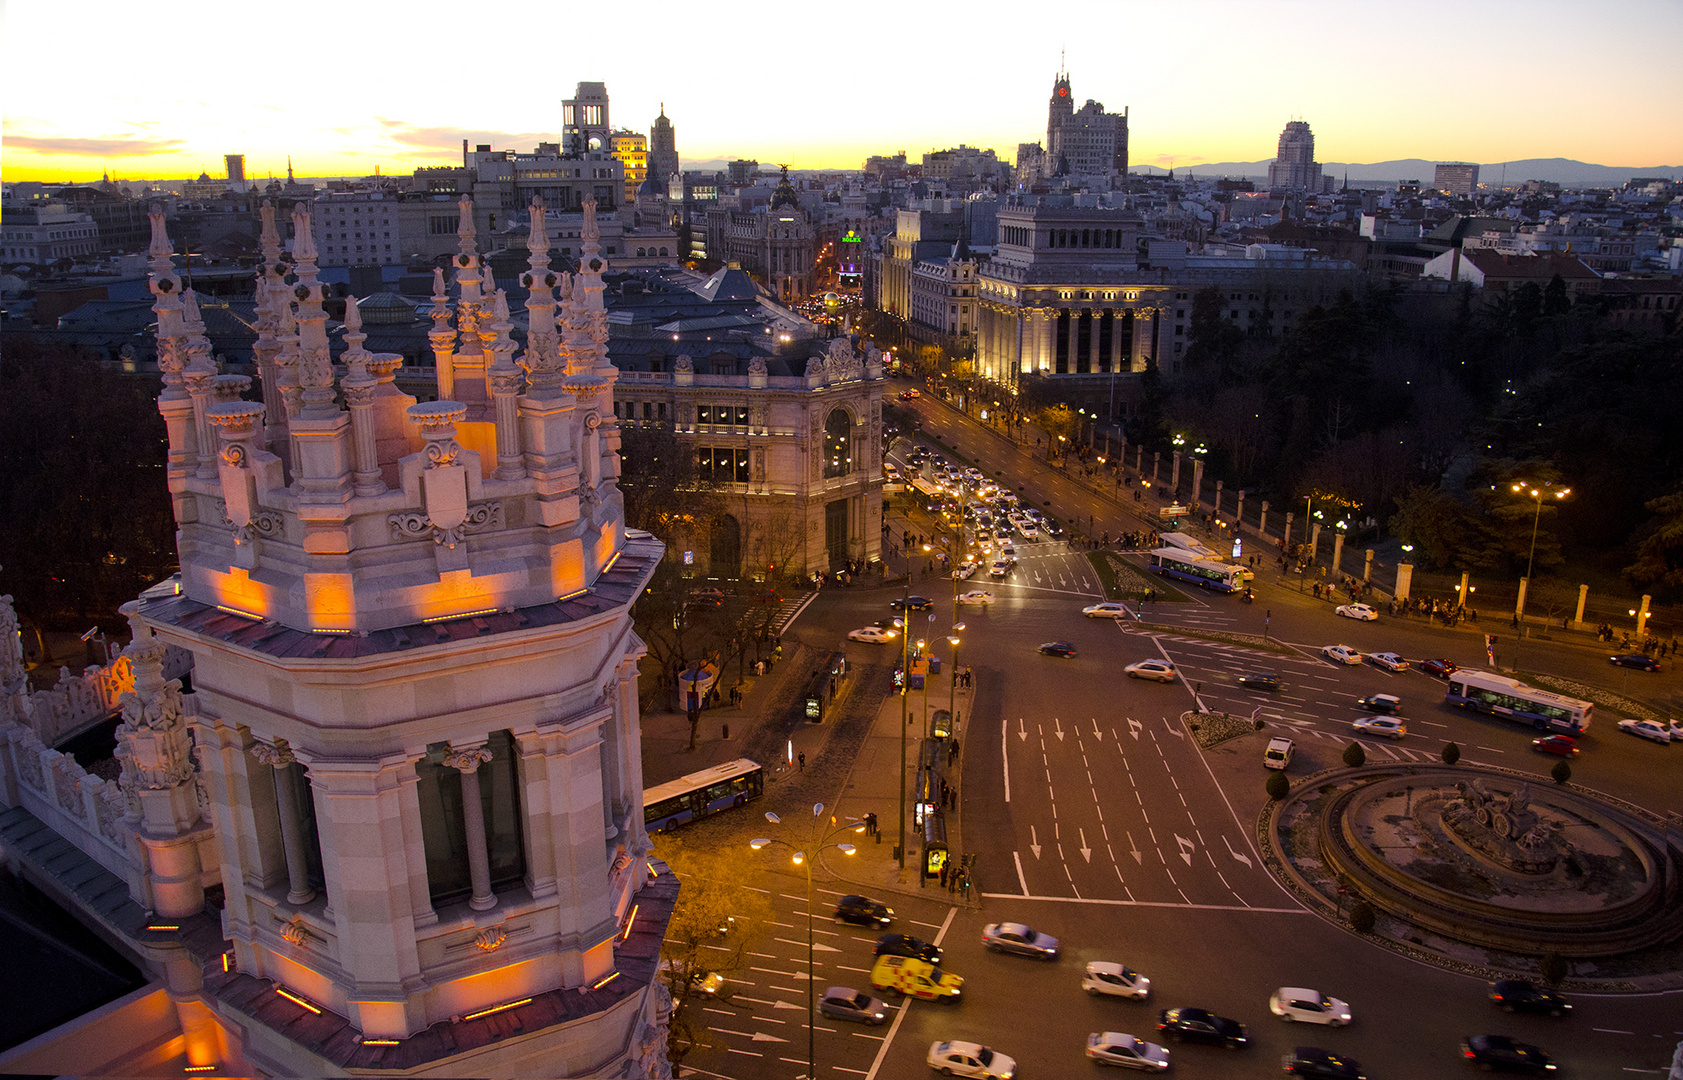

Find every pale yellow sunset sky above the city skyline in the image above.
[0,0,1683,180]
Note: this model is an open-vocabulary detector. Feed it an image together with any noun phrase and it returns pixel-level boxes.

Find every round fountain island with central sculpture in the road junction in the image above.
[1259,764,1683,993]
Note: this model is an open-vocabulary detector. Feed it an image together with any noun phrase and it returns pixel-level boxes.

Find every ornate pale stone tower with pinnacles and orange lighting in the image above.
[119,202,675,1077]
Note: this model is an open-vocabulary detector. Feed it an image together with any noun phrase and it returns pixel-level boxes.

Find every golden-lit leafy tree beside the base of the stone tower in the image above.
[656,834,771,1073]
